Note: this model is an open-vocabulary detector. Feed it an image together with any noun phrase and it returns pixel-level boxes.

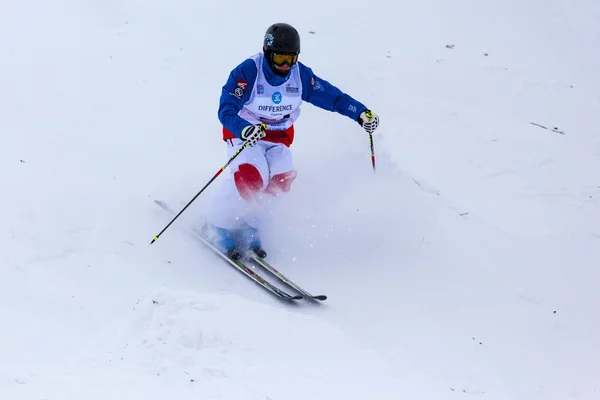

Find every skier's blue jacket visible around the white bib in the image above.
[218,54,367,137]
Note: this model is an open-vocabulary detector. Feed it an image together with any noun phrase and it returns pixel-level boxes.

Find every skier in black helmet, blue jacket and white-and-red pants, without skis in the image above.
[202,23,379,259]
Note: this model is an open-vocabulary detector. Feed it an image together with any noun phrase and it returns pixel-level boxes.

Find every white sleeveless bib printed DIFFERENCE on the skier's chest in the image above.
[238,53,302,130]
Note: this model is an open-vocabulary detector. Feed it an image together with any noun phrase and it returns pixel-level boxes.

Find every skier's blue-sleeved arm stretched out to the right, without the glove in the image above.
[298,63,367,122]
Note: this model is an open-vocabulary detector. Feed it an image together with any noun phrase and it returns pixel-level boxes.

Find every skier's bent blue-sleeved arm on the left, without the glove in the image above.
[218,59,257,137]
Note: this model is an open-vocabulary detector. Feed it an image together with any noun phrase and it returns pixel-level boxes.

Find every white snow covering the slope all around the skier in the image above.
[0,0,600,400]
